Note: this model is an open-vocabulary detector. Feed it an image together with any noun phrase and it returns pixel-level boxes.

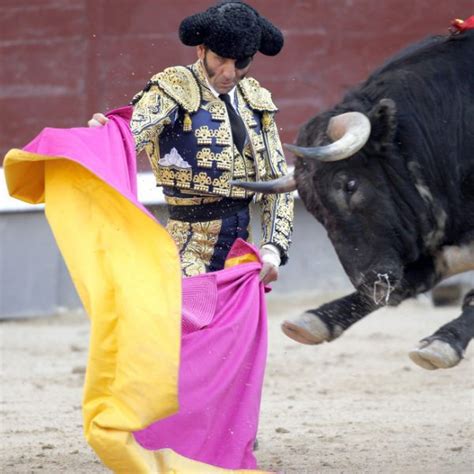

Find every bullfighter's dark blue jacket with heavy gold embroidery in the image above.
[131,61,293,262]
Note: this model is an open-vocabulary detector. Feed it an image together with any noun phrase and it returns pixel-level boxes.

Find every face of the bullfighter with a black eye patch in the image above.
[197,45,252,94]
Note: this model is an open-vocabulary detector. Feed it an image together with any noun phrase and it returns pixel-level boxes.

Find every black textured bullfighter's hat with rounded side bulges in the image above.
[179,0,284,60]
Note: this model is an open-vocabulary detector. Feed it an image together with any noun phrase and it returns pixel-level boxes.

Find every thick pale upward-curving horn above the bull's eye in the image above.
[285,112,370,161]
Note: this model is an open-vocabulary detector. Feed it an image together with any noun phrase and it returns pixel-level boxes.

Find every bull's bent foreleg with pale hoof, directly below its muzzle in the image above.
[282,291,380,344]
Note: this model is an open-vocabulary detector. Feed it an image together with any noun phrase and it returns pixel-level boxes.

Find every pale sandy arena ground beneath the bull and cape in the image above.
[0,295,474,474]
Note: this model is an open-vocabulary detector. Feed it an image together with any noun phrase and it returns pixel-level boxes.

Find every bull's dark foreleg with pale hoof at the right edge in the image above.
[409,290,474,370]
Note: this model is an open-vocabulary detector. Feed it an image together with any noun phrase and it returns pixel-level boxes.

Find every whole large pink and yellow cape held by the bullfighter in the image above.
[4,107,267,473]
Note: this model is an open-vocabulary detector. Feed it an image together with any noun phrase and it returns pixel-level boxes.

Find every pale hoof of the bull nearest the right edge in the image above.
[408,339,462,370]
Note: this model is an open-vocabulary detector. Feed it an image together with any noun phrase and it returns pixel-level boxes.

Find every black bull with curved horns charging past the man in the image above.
[235,30,474,369]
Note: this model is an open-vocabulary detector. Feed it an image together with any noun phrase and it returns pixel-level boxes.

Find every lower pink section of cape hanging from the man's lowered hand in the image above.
[135,240,267,469]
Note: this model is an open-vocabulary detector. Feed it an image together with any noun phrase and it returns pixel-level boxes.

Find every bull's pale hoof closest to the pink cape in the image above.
[281,313,342,344]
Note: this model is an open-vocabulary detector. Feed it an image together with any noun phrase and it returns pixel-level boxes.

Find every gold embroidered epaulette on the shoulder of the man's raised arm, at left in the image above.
[150,66,201,113]
